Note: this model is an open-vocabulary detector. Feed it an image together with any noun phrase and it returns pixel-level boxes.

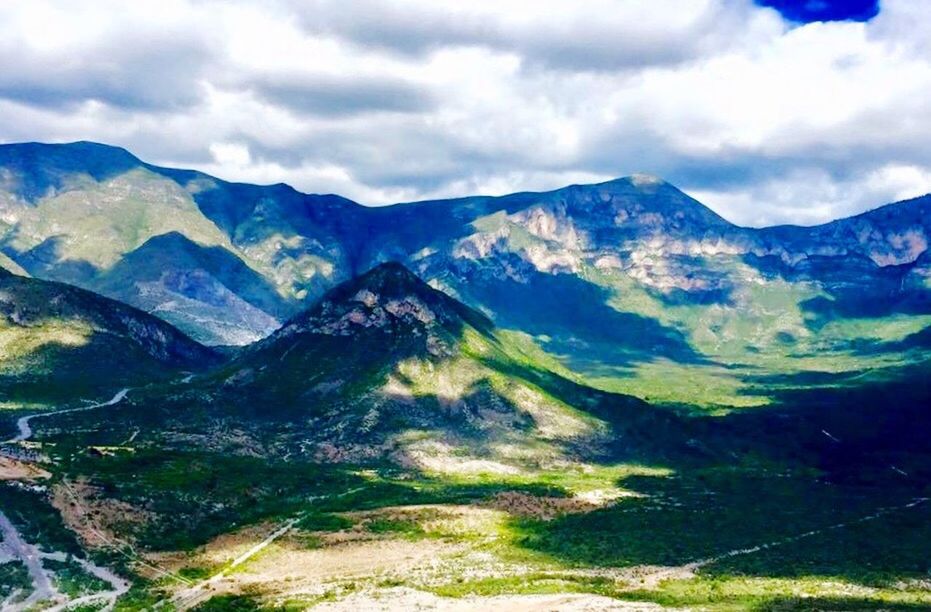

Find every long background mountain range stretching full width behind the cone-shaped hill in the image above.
[0,143,931,409]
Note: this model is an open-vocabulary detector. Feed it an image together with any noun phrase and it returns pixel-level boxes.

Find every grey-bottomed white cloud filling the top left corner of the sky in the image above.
[0,2,213,111]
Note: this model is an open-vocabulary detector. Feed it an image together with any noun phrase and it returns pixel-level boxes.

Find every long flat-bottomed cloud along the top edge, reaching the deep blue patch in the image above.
[285,0,778,70]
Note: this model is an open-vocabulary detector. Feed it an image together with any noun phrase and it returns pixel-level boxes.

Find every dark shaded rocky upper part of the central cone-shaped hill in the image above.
[240,262,493,402]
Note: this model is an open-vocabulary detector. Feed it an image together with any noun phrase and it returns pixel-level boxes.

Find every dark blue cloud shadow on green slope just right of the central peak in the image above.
[461,271,708,370]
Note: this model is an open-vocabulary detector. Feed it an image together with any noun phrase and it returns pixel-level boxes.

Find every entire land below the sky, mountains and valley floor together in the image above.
[0,143,931,611]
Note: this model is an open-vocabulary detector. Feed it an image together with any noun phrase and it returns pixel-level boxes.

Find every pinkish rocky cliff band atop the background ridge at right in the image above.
[418,175,931,316]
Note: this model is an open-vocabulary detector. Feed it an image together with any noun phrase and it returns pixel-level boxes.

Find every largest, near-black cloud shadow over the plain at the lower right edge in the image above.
[480,354,931,588]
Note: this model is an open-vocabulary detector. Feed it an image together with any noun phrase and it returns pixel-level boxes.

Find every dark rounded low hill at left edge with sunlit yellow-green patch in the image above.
[0,262,219,401]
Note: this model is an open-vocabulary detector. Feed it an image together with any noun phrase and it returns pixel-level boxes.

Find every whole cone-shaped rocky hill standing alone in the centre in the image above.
[208,263,624,471]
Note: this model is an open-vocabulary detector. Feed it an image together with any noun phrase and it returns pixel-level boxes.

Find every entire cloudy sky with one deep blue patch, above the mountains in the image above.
[0,0,931,226]
